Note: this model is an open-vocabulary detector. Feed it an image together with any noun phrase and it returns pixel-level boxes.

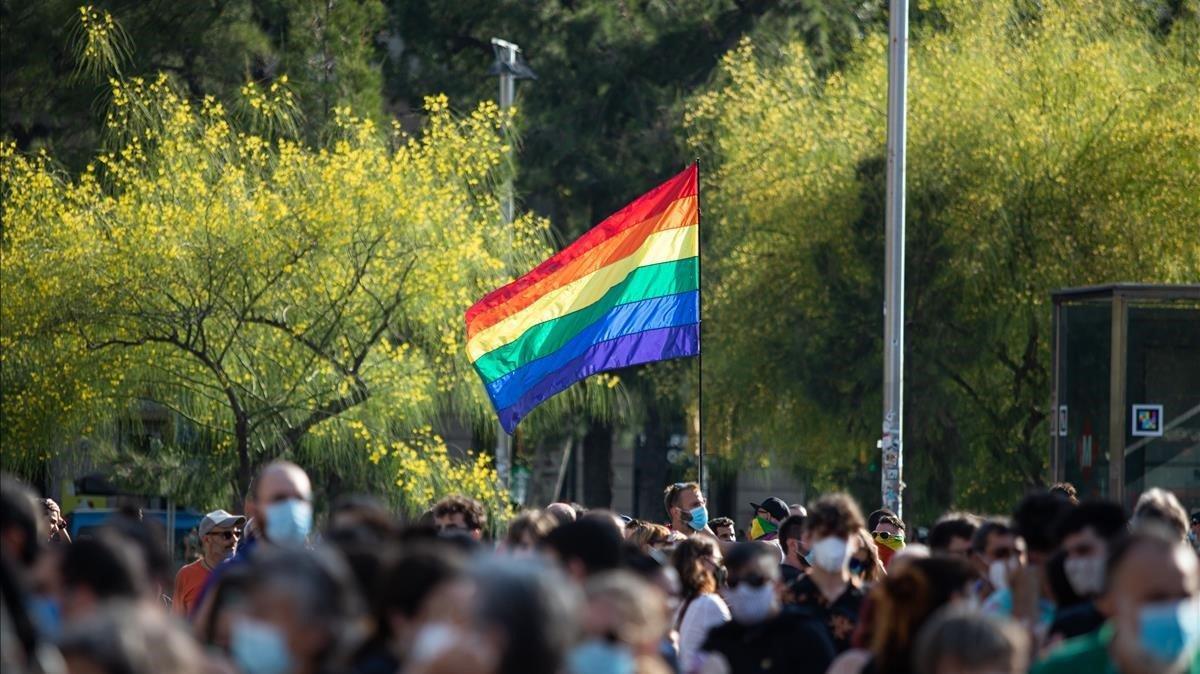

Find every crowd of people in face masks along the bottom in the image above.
[0,462,1200,674]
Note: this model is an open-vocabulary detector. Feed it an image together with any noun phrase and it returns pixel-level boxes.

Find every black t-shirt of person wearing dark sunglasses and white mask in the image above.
[701,608,836,674]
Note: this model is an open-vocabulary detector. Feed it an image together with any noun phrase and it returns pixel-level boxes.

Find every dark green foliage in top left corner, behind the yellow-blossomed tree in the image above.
[0,0,384,164]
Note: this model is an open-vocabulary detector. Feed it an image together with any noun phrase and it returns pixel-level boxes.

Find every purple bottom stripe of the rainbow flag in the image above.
[499,323,700,435]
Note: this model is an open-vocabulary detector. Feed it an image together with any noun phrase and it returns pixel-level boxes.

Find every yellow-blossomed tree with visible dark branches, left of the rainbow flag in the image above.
[0,8,611,520]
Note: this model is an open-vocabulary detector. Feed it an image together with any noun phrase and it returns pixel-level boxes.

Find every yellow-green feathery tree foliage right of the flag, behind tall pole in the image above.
[688,0,1200,517]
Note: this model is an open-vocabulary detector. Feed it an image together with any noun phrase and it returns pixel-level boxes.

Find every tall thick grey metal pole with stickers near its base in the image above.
[880,0,908,517]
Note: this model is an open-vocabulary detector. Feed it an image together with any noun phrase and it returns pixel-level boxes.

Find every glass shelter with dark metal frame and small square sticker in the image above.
[1050,284,1200,512]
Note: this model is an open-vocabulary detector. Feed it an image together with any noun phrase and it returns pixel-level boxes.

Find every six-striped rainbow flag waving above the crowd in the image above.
[467,164,700,434]
